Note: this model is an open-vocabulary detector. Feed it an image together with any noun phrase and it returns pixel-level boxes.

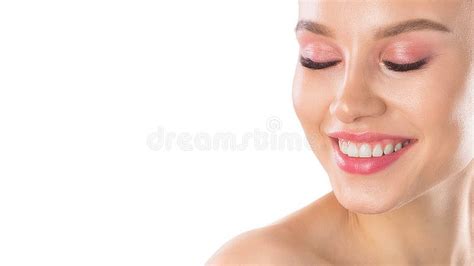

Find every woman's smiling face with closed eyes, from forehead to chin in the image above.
[293,0,474,213]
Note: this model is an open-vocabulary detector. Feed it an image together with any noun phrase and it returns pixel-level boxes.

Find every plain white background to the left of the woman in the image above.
[0,0,330,265]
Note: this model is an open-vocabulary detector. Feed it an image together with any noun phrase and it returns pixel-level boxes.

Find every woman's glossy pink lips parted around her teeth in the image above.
[328,131,417,175]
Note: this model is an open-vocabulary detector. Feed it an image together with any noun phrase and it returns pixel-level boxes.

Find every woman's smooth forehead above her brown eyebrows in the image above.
[299,0,472,38]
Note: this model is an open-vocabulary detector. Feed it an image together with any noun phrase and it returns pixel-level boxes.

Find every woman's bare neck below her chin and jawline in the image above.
[348,160,474,265]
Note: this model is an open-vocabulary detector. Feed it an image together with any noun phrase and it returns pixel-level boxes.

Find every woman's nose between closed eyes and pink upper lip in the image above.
[329,58,386,123]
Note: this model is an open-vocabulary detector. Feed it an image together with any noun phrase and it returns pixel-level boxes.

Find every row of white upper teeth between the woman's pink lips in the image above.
[339,139,410,157]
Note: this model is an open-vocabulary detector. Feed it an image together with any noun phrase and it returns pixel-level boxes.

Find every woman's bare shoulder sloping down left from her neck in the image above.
[206,192,340,266]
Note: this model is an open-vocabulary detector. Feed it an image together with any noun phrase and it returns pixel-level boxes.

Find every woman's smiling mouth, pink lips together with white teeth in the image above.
[328,132,417,175]
